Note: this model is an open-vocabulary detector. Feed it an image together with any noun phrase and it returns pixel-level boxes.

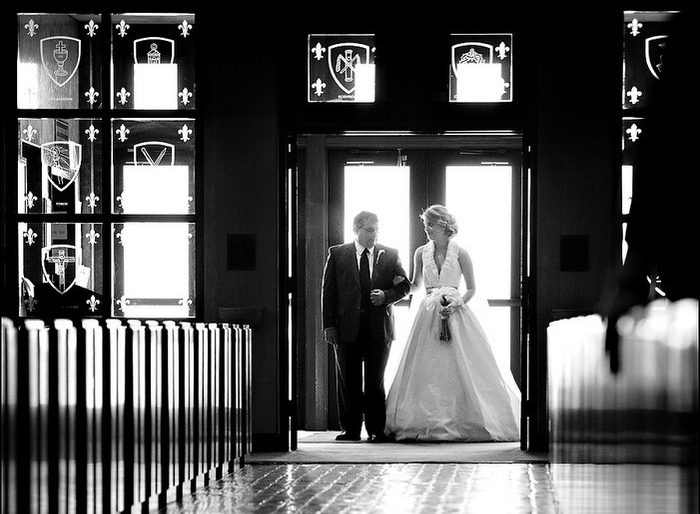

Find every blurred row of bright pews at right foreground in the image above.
[547,299,699,513]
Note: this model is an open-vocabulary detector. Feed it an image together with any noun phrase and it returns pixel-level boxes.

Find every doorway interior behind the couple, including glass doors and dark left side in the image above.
[295,133,527,444]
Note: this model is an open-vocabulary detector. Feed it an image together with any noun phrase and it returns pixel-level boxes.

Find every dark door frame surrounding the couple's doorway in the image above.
[287,131,538,450]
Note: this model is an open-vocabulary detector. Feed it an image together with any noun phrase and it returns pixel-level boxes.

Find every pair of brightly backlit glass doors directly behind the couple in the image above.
[329,144,521,392]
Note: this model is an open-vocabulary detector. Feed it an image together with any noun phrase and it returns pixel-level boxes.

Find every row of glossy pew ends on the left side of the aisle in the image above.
[0,318,252,513]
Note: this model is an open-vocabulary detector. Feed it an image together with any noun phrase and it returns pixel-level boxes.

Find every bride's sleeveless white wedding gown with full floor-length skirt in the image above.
[385,241,520,442]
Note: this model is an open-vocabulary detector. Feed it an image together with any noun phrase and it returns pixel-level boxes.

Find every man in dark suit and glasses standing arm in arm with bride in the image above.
[321,211,410,442]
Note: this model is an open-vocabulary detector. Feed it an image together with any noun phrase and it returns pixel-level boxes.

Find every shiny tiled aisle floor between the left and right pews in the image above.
[159,463,558,514]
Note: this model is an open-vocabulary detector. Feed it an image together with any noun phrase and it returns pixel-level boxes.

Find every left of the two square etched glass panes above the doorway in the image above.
[307,34,375,103]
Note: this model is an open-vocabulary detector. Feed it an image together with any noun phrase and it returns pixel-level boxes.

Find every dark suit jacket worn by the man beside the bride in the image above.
[321,242,411,343]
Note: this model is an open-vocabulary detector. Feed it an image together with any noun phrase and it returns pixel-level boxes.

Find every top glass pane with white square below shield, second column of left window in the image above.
[111,13,196,110]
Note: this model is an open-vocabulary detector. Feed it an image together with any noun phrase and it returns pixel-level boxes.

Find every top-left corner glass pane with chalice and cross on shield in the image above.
[17,14,104,109]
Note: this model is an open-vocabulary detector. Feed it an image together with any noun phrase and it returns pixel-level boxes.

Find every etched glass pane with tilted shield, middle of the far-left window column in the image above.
[17,118,102,214]
